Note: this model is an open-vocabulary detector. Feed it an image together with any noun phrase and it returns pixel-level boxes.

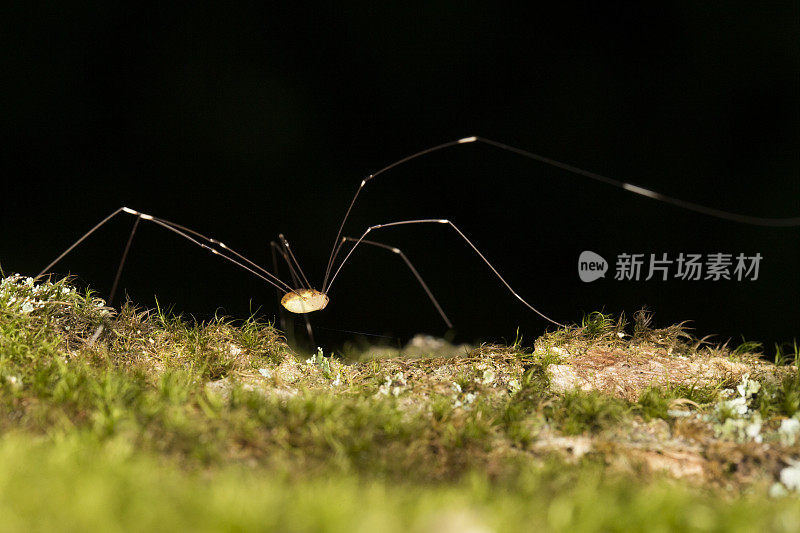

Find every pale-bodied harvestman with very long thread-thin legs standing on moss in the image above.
[38,137,800,340]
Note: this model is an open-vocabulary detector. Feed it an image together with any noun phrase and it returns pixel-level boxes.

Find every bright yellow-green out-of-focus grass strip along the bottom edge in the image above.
[0,433,800,532]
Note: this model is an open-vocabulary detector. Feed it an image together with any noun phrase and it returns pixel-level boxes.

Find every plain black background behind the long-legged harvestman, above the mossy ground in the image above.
[0,2,800,354]
